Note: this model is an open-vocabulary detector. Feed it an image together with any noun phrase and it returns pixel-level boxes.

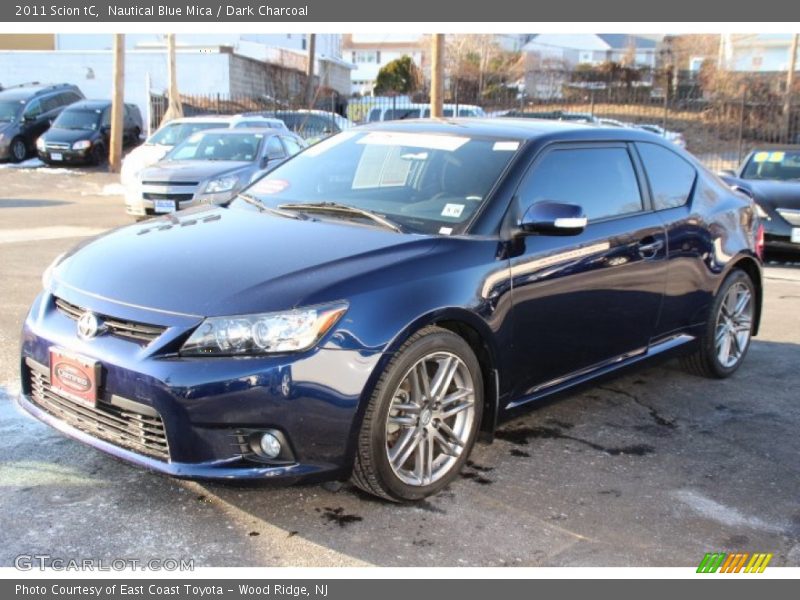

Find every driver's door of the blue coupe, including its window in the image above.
[511,143,666,399]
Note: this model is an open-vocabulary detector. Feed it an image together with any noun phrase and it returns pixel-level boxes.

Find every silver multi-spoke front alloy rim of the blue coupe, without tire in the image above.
[386,352,475,486]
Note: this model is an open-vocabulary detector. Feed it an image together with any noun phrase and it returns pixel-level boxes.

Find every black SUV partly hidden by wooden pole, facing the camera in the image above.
[36,100,142,165]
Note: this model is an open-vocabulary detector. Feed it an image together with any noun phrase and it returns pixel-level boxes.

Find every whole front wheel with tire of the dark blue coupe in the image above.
[352,326,483,502]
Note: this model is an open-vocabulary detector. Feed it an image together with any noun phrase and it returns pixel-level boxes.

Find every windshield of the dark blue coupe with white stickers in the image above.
[234,131,521,235]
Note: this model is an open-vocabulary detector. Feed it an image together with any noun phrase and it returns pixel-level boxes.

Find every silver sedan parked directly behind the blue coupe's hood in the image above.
[128,128,307,218]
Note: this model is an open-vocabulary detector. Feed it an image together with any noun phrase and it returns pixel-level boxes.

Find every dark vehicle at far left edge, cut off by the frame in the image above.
[0,83,83,162]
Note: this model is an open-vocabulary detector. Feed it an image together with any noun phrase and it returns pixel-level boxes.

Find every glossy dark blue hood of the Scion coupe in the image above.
[50,207,438,316]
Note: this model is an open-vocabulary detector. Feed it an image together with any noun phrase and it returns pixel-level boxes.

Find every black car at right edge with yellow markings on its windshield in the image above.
[722,146,800,253]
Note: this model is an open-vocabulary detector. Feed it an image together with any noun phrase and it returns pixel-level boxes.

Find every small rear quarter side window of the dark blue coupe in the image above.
[636,142,697,210]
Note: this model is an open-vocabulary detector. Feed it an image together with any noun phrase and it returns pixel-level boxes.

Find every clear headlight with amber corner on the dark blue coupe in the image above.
[181,302,347,356]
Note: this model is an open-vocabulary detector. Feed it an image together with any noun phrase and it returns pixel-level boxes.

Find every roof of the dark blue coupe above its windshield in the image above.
[359,117,662,142]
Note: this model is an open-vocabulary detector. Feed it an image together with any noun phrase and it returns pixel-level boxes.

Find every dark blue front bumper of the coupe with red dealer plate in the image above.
[18,294,379,483]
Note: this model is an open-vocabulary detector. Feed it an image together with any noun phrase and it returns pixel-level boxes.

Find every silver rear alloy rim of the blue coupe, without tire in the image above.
[714,282,753,369]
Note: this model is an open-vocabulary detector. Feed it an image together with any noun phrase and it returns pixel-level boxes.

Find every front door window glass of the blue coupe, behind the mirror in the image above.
[519,147,643,220]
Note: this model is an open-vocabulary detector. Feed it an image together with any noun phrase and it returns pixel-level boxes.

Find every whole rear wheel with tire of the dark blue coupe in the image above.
[681,269,756,379]
